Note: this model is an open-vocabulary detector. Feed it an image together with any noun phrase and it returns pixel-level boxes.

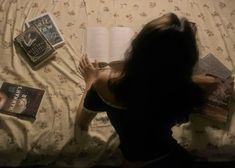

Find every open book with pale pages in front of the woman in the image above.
[85,27,134,64]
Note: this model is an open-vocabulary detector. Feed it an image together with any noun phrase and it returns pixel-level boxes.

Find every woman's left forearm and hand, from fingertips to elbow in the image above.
[77,55,99,130]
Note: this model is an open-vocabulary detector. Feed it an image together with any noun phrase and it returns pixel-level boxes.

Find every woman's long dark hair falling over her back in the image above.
[109,13,202,122]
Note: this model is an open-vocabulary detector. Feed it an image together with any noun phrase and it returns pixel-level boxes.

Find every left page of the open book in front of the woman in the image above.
[85,27,109,63]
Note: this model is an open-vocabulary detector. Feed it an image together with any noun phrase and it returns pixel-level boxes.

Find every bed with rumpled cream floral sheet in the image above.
[0,0,235,168]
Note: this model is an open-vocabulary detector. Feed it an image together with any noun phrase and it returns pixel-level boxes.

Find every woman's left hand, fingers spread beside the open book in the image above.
[79,54,99,88]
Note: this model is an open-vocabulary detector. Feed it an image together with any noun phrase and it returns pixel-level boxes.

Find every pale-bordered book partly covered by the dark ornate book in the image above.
[25,13,64,48]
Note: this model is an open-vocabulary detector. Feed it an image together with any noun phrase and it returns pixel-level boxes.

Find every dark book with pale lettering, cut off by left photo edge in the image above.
[0,82,45,118]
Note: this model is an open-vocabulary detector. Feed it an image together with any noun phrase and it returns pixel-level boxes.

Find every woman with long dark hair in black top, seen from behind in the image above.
[78,13,217,168]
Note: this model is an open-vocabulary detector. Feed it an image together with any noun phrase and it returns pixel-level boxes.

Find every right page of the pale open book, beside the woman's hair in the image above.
[109,27,134,62]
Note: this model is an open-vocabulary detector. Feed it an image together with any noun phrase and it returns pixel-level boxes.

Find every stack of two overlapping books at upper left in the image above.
[15,13,64,69]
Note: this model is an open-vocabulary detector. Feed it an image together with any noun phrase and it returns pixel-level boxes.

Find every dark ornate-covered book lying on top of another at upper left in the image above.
[15,25,55,68]
